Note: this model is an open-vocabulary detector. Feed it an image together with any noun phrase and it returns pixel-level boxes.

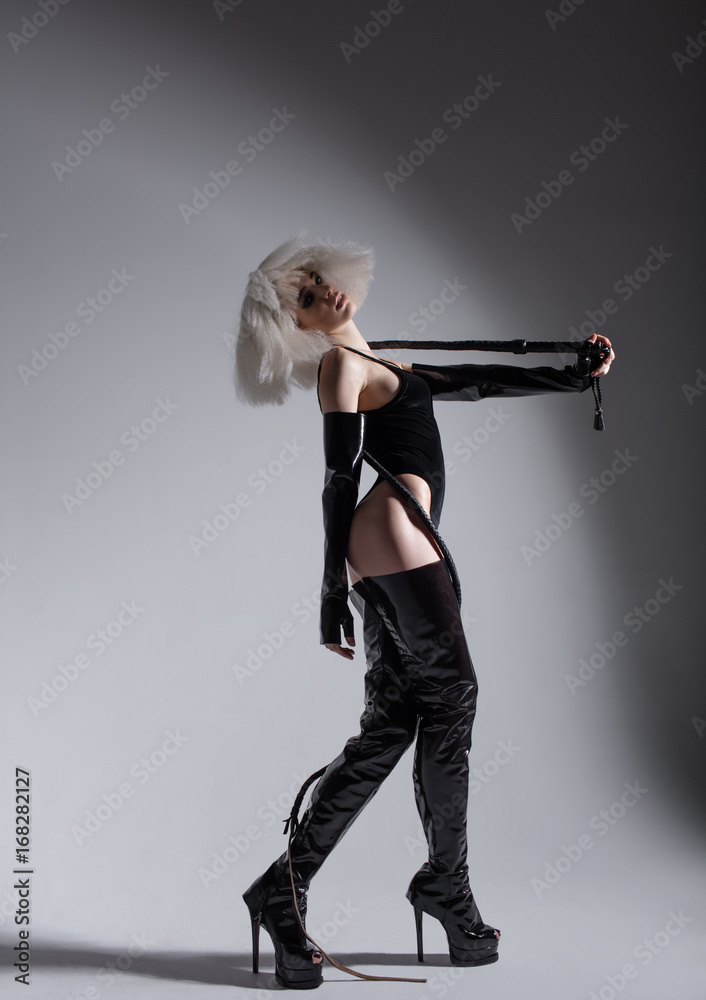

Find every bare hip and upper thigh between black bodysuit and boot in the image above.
[348,473,442,583]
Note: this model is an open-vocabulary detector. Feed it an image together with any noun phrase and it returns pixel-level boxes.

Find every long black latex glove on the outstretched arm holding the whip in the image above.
[412,359,591,402]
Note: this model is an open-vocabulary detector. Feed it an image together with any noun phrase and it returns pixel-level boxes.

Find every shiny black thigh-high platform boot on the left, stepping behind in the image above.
[243,594,417,989]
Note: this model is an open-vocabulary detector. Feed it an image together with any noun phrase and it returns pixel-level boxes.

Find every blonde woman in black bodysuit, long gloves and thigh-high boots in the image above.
[235,234,615,989]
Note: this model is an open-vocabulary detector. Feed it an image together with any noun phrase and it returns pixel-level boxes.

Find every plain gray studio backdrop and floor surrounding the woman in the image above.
[0,0,706,1000]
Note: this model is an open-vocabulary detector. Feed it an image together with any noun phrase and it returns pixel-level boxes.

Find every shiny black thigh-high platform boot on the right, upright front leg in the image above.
[354,561,499,965]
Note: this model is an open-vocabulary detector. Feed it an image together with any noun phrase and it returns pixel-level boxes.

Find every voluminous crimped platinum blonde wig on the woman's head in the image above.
[233,232,375,406]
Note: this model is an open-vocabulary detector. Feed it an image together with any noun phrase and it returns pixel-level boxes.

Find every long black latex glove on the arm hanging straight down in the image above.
[320,411,365,644]
